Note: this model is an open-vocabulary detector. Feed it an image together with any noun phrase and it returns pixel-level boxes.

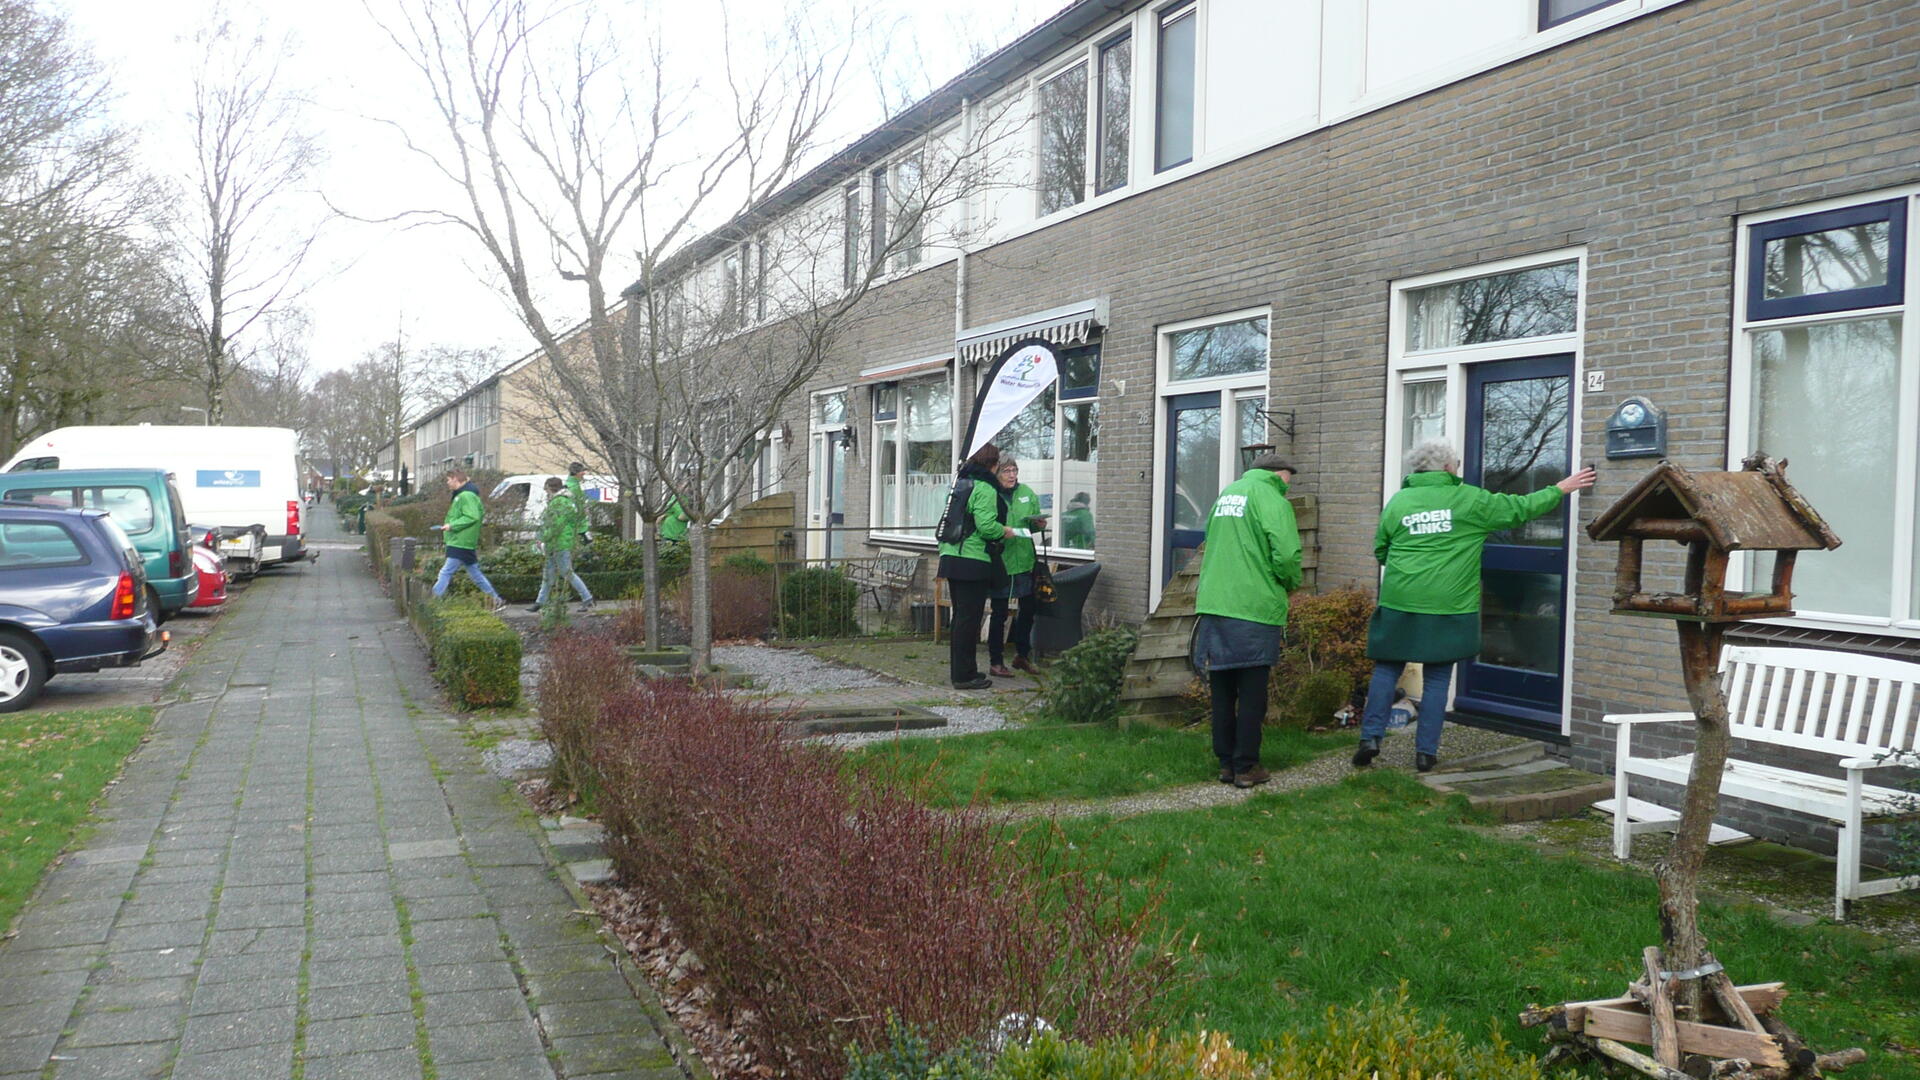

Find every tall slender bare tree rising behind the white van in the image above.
[179,13,321,423]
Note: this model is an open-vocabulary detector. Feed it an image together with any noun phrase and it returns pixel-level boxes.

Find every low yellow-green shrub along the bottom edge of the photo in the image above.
[847,988,1540,1080]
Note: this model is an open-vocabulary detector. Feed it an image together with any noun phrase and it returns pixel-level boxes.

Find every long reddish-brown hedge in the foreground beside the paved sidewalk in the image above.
[576,676,1173,1080]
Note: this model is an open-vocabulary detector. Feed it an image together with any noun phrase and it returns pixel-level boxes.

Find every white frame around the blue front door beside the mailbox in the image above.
[1380,248,1588,734]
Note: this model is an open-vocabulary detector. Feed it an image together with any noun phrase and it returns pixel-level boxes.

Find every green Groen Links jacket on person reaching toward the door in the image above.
[1373,473,1563,615]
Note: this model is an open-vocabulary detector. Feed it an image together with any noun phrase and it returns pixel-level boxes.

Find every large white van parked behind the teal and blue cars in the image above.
[0,425,309,577]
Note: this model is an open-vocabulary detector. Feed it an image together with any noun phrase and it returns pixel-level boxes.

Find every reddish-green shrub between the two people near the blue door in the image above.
[1267,588,1373,726]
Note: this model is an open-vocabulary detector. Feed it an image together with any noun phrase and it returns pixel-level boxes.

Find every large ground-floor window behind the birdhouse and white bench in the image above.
[1728,192,1920,618]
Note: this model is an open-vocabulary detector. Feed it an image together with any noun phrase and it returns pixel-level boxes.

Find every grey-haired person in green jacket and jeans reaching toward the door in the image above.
[1354,438,1594,773]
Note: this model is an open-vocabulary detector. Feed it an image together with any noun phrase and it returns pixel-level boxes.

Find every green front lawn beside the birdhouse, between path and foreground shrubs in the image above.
[1062,774,1920,1080]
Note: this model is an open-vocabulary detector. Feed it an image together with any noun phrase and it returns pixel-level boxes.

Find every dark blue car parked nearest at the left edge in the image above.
[0,503,167,713]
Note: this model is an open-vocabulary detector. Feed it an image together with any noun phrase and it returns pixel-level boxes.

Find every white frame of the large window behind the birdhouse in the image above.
[1726,184,1920,638]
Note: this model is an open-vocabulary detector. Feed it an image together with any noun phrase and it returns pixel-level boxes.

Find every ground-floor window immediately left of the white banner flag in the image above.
[874,375,954,538]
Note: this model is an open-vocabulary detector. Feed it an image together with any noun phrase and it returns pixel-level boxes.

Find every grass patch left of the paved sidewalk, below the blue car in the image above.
[0,705,154,930]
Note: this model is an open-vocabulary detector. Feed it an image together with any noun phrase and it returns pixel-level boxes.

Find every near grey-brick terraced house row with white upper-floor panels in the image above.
[435,0,1920,842]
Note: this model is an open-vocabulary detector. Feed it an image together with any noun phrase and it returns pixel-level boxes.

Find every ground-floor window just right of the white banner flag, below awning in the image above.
[993,346,1100,552]
